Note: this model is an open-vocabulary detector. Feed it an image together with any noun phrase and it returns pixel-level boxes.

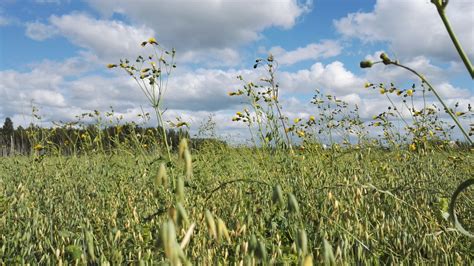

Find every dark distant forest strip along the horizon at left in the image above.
[0,117,224,156]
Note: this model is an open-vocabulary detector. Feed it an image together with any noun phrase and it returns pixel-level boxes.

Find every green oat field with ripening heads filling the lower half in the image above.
[0,143,474,265]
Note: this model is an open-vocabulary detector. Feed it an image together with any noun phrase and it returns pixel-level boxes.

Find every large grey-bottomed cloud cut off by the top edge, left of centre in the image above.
[84,0,311,50]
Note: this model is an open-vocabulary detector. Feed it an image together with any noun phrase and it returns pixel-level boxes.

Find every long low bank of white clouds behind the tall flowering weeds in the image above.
[0,53,473,139]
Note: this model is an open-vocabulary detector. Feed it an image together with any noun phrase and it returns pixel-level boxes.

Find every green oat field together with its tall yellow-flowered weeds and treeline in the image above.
[0,1,474,265]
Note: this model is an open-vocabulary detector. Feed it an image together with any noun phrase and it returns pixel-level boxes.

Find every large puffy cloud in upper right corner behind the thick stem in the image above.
[334,0,474,61]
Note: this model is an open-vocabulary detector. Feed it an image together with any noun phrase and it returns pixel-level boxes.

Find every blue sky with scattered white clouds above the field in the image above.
[0,0,474,140]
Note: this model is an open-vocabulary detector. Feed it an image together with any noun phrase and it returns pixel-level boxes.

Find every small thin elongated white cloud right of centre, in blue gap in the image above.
[269,40,342,65]
